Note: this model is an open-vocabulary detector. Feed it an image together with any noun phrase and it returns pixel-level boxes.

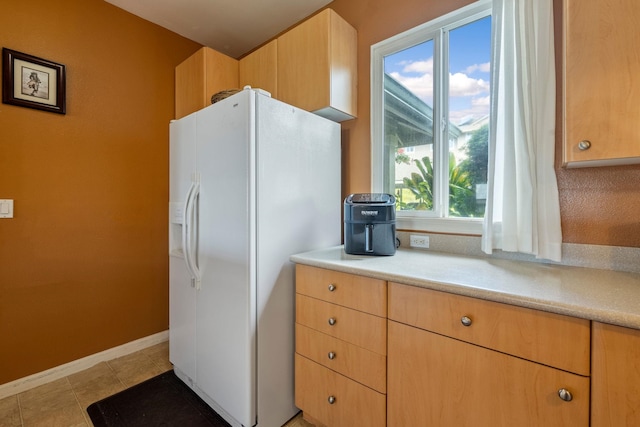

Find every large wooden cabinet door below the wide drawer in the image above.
[387,321,589,427]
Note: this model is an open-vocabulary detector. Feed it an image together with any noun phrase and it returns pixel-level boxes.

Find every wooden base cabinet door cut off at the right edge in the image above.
[591,322,640,427]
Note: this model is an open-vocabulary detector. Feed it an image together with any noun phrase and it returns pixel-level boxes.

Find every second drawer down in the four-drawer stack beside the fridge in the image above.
[296,294,387,355]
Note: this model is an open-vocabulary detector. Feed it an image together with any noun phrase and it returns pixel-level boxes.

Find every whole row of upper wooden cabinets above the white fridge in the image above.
[176,9,357,122]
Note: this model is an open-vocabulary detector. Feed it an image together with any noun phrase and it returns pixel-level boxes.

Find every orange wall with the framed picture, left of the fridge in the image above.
[0,0,200,384]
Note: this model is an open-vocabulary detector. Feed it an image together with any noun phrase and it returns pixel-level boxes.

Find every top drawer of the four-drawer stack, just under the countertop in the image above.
[296,264,387,317]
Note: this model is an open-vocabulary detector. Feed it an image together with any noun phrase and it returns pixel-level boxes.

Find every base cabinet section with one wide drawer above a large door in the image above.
[387,283,590,427]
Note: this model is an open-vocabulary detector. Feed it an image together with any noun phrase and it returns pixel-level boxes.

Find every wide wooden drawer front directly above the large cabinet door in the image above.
[389,283,591,375]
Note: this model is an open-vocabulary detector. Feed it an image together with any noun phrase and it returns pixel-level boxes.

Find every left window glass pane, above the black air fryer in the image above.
[383,40,434,211]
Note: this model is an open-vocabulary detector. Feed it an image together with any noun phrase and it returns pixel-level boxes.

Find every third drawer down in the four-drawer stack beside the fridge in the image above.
[296,323,387,393]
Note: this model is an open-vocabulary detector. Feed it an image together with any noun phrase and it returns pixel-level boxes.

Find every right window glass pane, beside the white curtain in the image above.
[448,16,491,217]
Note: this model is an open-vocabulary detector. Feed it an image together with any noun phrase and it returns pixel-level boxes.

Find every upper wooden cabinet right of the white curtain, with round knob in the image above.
[563,0,640,167]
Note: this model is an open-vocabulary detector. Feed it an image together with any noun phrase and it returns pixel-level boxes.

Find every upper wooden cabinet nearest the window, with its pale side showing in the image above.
[277,9,357,122]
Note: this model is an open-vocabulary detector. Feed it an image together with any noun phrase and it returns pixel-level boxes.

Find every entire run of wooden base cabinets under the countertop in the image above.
[295,265,640,427]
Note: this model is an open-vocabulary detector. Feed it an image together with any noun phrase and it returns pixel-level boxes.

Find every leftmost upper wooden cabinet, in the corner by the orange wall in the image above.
[175,47,238,119]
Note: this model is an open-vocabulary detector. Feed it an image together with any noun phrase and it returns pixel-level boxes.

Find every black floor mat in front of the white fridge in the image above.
[87,371,230,427]
